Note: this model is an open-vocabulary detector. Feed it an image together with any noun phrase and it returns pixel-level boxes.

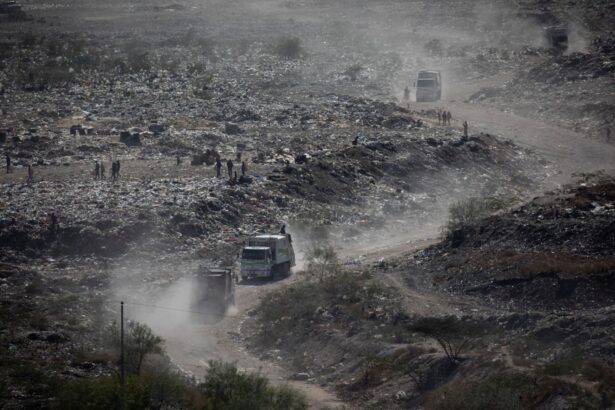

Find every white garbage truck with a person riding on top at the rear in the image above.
[240,234,295,279]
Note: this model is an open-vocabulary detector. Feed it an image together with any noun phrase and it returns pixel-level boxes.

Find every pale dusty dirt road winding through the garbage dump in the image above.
[154,77,615,408]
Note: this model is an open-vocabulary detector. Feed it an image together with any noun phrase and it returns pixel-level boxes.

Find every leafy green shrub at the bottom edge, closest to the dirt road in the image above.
[199,361,307,410]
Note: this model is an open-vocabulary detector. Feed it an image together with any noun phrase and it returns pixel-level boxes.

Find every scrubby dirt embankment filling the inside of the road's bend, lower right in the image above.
[244,176,615,408]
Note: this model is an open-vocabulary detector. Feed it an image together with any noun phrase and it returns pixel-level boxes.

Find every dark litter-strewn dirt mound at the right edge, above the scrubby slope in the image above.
[418,175,615,308]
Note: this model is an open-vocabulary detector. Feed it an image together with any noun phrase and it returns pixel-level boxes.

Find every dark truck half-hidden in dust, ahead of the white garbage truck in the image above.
[192,266,236,316]
